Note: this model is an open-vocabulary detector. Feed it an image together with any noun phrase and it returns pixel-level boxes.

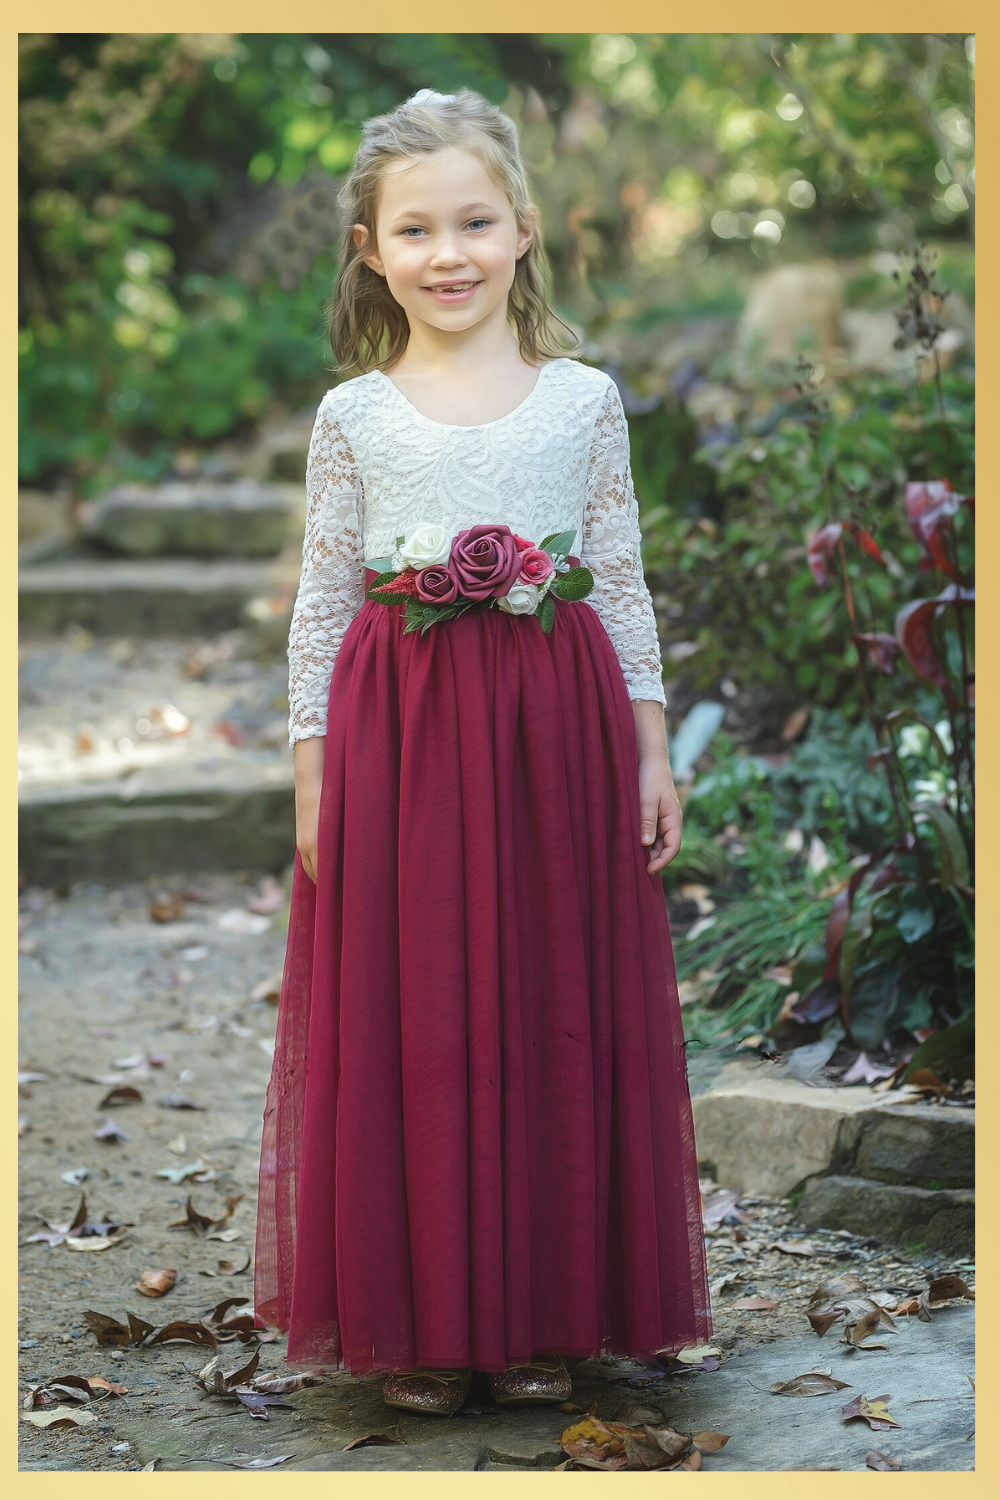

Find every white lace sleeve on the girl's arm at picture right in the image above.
[580,383,666,704]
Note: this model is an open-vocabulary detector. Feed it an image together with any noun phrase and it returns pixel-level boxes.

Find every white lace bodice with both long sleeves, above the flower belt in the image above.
[288,359,666,743]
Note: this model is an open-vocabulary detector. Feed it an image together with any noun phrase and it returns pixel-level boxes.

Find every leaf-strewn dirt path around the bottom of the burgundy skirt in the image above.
[18,876,971,1470]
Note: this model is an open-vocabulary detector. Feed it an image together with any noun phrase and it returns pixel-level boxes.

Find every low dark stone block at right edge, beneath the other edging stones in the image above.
[795,1176,976,1257]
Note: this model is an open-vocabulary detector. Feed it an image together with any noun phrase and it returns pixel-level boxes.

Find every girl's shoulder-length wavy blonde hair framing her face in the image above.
[327,89,580,375]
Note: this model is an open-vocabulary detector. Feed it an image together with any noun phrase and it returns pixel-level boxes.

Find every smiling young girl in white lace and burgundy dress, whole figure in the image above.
[256,89,711,1415]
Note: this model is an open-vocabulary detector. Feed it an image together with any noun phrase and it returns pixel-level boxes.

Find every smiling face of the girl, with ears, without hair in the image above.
[354,147,534,333]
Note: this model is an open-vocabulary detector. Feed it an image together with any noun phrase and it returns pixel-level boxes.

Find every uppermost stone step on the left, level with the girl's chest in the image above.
[81,479,303,558]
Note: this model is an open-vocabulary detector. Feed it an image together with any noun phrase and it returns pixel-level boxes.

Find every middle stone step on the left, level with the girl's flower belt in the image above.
[18,557,298,635]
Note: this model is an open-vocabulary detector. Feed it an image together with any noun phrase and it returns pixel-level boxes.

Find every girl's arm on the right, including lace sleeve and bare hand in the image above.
[580,381,682,875]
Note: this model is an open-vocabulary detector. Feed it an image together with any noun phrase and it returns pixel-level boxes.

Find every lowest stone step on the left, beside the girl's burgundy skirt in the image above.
[18,756,295,887]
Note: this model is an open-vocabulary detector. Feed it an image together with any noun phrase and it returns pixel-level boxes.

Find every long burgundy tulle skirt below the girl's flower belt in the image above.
[255,570,711,1374]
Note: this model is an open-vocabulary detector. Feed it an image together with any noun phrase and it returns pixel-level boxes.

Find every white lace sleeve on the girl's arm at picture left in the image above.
[288,402,364,744]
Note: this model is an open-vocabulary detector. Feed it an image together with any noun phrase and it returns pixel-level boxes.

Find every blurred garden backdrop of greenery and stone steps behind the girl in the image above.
[19,33,976,1094]
